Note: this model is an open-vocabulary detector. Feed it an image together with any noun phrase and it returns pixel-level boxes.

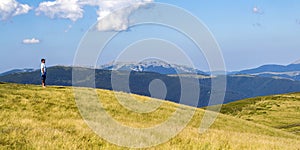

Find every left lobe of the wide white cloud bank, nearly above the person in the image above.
[36,0,84,21]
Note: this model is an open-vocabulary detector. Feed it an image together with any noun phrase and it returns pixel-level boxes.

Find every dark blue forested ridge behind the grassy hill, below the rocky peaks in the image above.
[0,66,300,107]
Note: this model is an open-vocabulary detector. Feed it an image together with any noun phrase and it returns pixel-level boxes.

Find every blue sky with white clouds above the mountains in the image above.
[0,0,300,73]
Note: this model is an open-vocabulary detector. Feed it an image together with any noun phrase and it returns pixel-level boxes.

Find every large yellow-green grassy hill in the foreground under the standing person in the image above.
[0,83,300,149]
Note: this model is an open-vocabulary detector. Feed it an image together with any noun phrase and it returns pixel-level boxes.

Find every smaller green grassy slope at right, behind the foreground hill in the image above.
[221,93,300,135]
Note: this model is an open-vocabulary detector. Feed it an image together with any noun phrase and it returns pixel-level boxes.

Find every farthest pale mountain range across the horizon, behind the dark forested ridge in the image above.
[0,59,300,81]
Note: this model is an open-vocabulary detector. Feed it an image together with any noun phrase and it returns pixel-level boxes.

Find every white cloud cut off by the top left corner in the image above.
[0,0,32,20]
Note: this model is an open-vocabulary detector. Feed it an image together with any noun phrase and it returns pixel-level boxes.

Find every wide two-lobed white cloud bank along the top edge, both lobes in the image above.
[36,0,153,31]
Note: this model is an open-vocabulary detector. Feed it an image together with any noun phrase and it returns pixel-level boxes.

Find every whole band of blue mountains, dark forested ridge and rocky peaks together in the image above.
[0,60,300,107]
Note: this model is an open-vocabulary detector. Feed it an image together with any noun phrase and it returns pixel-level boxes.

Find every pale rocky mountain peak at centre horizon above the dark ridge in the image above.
[99,59,208,75]
